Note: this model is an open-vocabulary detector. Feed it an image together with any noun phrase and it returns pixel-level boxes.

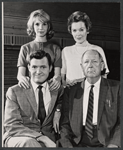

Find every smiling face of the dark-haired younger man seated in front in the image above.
[28,57,52,84]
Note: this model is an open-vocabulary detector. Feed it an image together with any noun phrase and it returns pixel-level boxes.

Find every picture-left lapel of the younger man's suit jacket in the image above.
[24,84,38,116]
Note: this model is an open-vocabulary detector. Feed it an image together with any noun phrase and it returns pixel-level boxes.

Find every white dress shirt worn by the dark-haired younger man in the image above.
[31,80,51,115]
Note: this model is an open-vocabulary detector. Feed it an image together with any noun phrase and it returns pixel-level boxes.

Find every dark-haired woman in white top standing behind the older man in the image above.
[61,11,109,86]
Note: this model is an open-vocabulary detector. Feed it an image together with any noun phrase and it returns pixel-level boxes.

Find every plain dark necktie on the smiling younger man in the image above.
[38,86,46,124]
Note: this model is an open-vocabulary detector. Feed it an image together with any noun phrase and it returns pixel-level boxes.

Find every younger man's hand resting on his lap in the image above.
[37,135,56,147]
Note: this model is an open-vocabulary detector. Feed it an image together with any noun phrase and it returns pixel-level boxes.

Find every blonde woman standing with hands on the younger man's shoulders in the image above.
[17,9,62,90]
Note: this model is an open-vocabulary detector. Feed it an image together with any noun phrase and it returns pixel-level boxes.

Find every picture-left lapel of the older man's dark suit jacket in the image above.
[69,82,84,136]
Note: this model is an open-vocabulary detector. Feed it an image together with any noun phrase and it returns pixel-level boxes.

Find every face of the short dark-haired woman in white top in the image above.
[71,21,89,44]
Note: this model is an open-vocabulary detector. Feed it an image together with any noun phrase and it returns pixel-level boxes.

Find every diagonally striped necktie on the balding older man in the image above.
[85,85,94,139]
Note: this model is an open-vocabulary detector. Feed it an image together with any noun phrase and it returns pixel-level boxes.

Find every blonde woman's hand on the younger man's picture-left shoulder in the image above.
[18,76,30,89]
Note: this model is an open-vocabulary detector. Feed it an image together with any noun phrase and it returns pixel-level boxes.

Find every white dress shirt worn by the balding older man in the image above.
[83,77,101,125]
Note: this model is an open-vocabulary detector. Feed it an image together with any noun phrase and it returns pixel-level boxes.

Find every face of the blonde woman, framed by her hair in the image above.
[34,17,48,37]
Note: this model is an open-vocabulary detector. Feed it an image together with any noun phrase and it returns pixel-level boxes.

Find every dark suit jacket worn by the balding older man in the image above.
[60,78,121,147]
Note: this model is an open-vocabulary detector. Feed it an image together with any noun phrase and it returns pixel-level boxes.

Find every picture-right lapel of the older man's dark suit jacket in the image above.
[97,78,108,126]
